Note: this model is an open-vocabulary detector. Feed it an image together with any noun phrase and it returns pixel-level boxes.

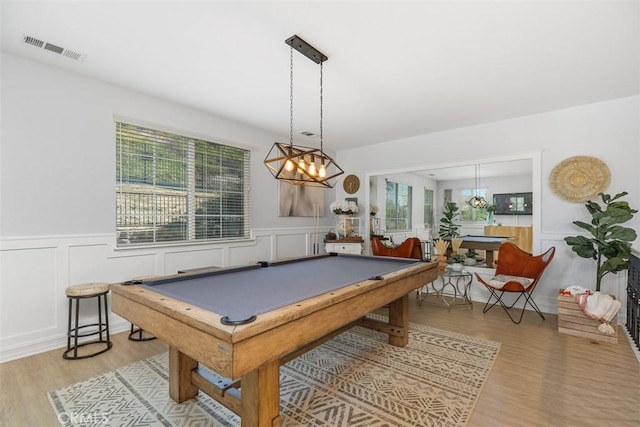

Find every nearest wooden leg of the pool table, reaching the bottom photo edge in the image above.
[240,360,280,427]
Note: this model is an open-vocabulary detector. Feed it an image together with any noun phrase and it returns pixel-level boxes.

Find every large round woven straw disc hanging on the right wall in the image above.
[549,156,611,202]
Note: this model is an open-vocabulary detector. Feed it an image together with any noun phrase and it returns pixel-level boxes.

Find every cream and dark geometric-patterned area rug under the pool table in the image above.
[48,318,500,427]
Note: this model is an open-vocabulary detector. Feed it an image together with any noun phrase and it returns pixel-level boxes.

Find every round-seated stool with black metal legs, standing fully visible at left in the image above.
[62,283,113,359]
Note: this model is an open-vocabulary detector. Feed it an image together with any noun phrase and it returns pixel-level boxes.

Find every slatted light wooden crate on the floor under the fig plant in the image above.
[558,293,618,344]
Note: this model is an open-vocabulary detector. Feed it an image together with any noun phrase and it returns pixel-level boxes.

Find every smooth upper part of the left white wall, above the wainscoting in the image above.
[0,53,334,238]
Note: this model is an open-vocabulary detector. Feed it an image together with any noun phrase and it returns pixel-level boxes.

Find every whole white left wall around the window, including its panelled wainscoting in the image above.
[0,53,335,361]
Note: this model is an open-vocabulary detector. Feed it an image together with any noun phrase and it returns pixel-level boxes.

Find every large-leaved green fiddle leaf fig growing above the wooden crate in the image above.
[564,191,638,292]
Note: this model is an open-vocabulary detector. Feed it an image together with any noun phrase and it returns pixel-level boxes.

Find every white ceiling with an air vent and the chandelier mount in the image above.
[1,0,640,155]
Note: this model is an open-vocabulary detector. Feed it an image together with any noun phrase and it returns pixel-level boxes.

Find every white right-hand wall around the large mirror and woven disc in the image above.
[337,96,640,316]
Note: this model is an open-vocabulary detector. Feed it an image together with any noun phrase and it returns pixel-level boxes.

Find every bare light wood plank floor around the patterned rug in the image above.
[0,294,640,427]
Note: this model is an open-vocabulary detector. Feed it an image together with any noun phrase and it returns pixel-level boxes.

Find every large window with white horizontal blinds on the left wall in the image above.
[116,123,250,246]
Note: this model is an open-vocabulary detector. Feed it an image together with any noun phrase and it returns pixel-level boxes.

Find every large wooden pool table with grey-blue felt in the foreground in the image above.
[111,253,437,426]
